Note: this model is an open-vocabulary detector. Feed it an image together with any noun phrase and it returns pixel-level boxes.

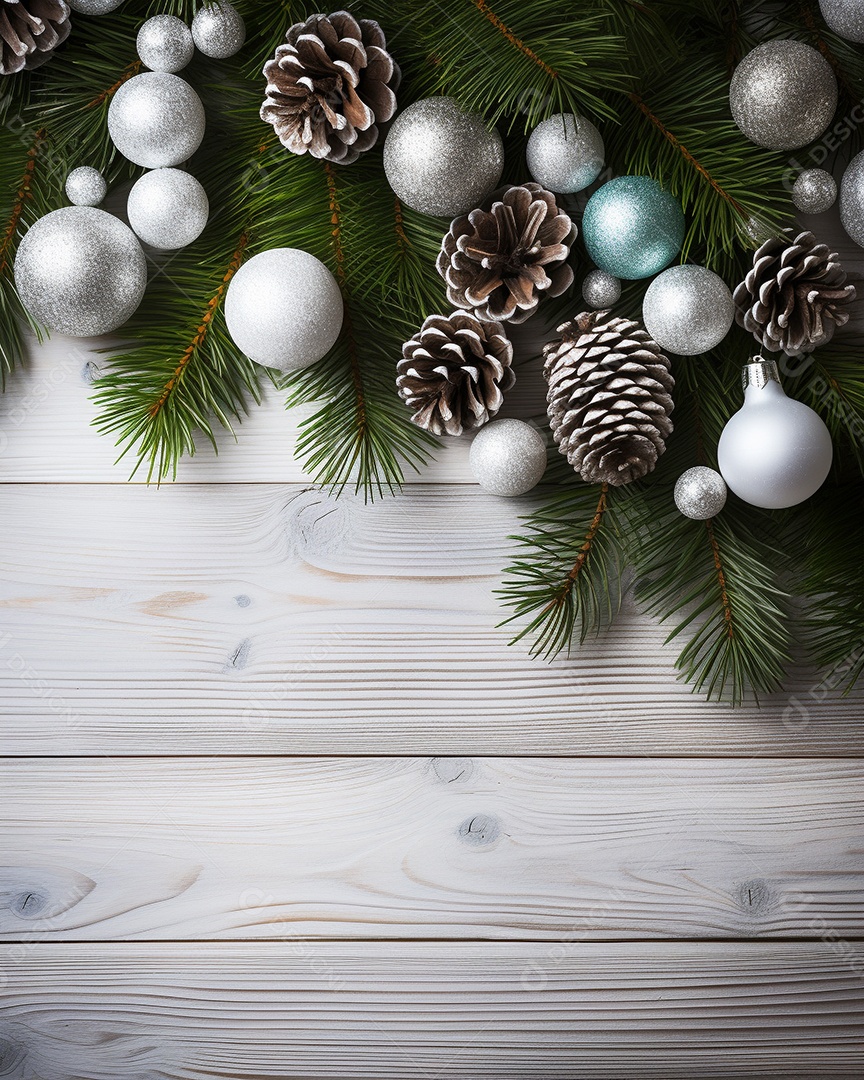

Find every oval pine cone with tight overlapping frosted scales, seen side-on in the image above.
[543,311,675,487]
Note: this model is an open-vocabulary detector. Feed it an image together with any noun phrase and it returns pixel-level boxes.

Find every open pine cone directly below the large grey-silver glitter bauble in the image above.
[437,184,577,323]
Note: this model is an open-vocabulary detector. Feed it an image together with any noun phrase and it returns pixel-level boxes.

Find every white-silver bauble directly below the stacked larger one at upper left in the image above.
[126,168,210,251]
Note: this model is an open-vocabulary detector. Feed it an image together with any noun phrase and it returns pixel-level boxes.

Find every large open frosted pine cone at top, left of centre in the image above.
[261,11,402,165]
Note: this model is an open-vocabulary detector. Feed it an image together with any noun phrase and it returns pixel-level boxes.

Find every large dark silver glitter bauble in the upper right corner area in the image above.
[729,41,837,150]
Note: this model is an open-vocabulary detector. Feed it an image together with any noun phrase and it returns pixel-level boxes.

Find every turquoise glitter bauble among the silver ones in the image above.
[582,176,684,281]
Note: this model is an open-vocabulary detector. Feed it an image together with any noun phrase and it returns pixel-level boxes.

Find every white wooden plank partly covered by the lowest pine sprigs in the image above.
[0,485,864,756]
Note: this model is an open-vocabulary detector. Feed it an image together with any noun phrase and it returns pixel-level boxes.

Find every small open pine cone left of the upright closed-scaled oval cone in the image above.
[396,311,516,435]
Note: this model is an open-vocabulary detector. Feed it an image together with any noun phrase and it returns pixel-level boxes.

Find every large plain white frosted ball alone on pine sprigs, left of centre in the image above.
[225,247,342,372]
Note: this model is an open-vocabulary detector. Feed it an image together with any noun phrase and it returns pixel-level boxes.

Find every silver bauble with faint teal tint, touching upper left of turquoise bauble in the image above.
[525,112,606,194]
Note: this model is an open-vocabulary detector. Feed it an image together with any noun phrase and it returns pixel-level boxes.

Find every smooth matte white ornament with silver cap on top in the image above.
[717,356,834,510]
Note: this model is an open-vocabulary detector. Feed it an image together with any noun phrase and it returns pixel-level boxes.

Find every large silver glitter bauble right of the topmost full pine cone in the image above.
[384,97,504,217]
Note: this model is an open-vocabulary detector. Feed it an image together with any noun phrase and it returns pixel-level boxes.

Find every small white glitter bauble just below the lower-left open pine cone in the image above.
[469,420,546,497]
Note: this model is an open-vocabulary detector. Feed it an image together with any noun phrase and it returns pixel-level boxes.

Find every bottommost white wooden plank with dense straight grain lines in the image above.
[0,940,864,1080]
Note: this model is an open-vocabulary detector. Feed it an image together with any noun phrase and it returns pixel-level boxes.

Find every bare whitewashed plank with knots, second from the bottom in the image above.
[0,758,864,941]
